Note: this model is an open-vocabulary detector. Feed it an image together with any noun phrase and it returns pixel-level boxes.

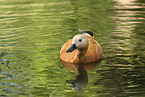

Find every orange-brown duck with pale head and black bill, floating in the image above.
[60,29,103,64]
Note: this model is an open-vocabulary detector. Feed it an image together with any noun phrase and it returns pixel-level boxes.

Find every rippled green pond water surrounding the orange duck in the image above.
[0,0,145,97]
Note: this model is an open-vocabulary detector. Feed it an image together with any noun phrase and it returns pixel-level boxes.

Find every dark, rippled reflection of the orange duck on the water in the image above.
[60,60,101,90]
